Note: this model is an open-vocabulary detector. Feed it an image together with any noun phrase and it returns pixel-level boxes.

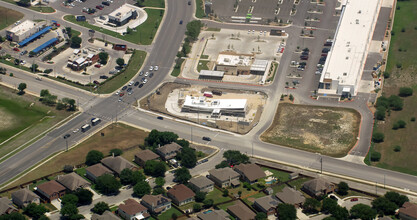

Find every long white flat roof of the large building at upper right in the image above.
[320,0,381,94]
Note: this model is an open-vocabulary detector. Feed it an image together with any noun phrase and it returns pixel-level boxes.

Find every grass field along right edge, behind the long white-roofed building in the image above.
[371,1,417,175]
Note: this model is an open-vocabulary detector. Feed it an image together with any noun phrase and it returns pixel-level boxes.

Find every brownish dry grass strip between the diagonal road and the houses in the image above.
[11,124,148,186]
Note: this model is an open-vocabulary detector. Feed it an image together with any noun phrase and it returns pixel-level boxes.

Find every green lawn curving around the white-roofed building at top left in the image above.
[64,8,164,45]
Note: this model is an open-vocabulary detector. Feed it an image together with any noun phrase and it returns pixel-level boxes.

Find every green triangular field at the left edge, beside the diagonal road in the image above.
[0,87,72,158]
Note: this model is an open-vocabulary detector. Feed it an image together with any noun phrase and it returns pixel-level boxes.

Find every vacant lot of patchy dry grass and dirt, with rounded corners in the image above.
[261,103,360,157]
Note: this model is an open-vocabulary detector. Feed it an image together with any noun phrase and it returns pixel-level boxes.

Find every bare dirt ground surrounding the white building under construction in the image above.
[140,83,266,134]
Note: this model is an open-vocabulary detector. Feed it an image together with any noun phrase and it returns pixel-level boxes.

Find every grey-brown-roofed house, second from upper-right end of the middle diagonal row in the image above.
[209,167,240,188]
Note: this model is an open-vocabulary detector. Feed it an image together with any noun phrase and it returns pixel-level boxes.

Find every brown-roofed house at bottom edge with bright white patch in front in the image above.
[117,199,151,220]
